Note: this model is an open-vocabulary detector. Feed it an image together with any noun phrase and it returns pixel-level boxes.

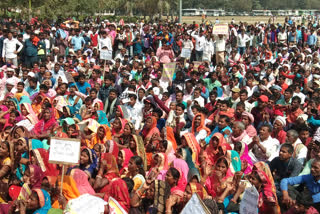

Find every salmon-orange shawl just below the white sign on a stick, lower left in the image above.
[70,169,95,195]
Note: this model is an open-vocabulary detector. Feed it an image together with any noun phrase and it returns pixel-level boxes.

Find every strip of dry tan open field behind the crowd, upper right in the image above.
[182,16,285,24]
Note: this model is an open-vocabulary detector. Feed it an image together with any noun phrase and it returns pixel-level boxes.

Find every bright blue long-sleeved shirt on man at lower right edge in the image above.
[280,174,320,203]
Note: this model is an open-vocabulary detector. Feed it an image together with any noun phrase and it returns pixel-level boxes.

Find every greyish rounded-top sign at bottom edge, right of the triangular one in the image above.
[240,186,259,214]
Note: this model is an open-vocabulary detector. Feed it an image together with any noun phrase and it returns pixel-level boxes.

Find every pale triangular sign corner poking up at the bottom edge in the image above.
[180,193,211,214]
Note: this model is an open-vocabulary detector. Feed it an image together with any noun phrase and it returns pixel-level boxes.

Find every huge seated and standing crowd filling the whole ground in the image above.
[0,14,320,214]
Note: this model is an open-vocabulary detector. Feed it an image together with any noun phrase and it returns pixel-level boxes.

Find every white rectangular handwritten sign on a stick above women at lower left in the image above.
[49,138,80,164]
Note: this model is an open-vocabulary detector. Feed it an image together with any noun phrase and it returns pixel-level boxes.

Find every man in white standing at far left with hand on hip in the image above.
[2,32,23,67]
